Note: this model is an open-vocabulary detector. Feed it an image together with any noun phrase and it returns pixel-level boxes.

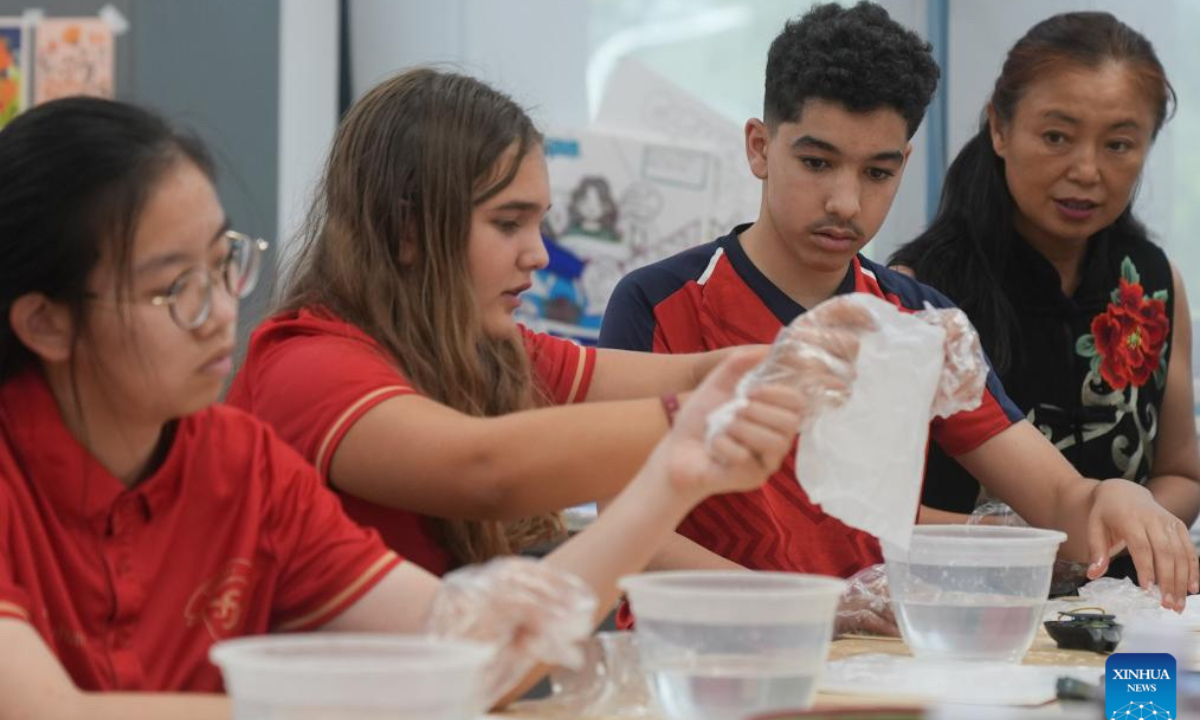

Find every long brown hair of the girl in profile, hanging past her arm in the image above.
[283,68,563,563]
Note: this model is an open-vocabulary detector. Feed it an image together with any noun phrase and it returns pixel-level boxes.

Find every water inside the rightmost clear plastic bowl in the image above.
[896,593,1044,662]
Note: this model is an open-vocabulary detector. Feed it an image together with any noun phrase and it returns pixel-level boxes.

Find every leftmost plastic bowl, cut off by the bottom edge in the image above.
[210,632,494,720]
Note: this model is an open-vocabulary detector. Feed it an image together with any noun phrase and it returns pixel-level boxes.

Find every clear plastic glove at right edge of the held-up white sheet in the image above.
[917,302,988,418]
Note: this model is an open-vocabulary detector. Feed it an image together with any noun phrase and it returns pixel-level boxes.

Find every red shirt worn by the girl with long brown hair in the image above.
[226,307,595,575]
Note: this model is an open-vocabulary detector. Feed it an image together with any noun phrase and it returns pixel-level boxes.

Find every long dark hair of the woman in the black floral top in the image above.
[889,12,1175,373]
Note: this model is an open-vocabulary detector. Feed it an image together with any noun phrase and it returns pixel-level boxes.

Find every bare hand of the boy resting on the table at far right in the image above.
[1087,479,1200,612]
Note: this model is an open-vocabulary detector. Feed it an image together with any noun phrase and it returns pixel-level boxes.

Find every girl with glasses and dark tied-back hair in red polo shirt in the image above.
[0,98,834,720]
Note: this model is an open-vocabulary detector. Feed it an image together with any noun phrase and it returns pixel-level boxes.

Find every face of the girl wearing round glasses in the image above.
[76,161,238,424]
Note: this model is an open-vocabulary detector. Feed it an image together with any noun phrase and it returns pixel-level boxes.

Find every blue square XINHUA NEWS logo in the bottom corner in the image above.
[1104,653,1177,720]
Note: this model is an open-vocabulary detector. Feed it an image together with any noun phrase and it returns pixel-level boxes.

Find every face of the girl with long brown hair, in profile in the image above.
[467,146,550,337]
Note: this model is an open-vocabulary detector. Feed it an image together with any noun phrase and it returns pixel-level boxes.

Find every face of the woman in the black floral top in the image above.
[991,62,1154,248]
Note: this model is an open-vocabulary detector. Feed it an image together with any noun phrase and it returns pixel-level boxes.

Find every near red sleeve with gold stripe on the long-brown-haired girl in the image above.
[242,335,415,478]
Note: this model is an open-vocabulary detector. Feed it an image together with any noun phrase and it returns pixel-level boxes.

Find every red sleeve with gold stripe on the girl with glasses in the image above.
[264,436,401,631]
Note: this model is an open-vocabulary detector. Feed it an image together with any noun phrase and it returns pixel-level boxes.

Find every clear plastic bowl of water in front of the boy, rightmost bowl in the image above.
[883,526,1067,662]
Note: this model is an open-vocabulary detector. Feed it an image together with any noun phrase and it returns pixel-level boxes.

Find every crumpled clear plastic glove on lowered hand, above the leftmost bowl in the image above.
[425,557,596,707]
